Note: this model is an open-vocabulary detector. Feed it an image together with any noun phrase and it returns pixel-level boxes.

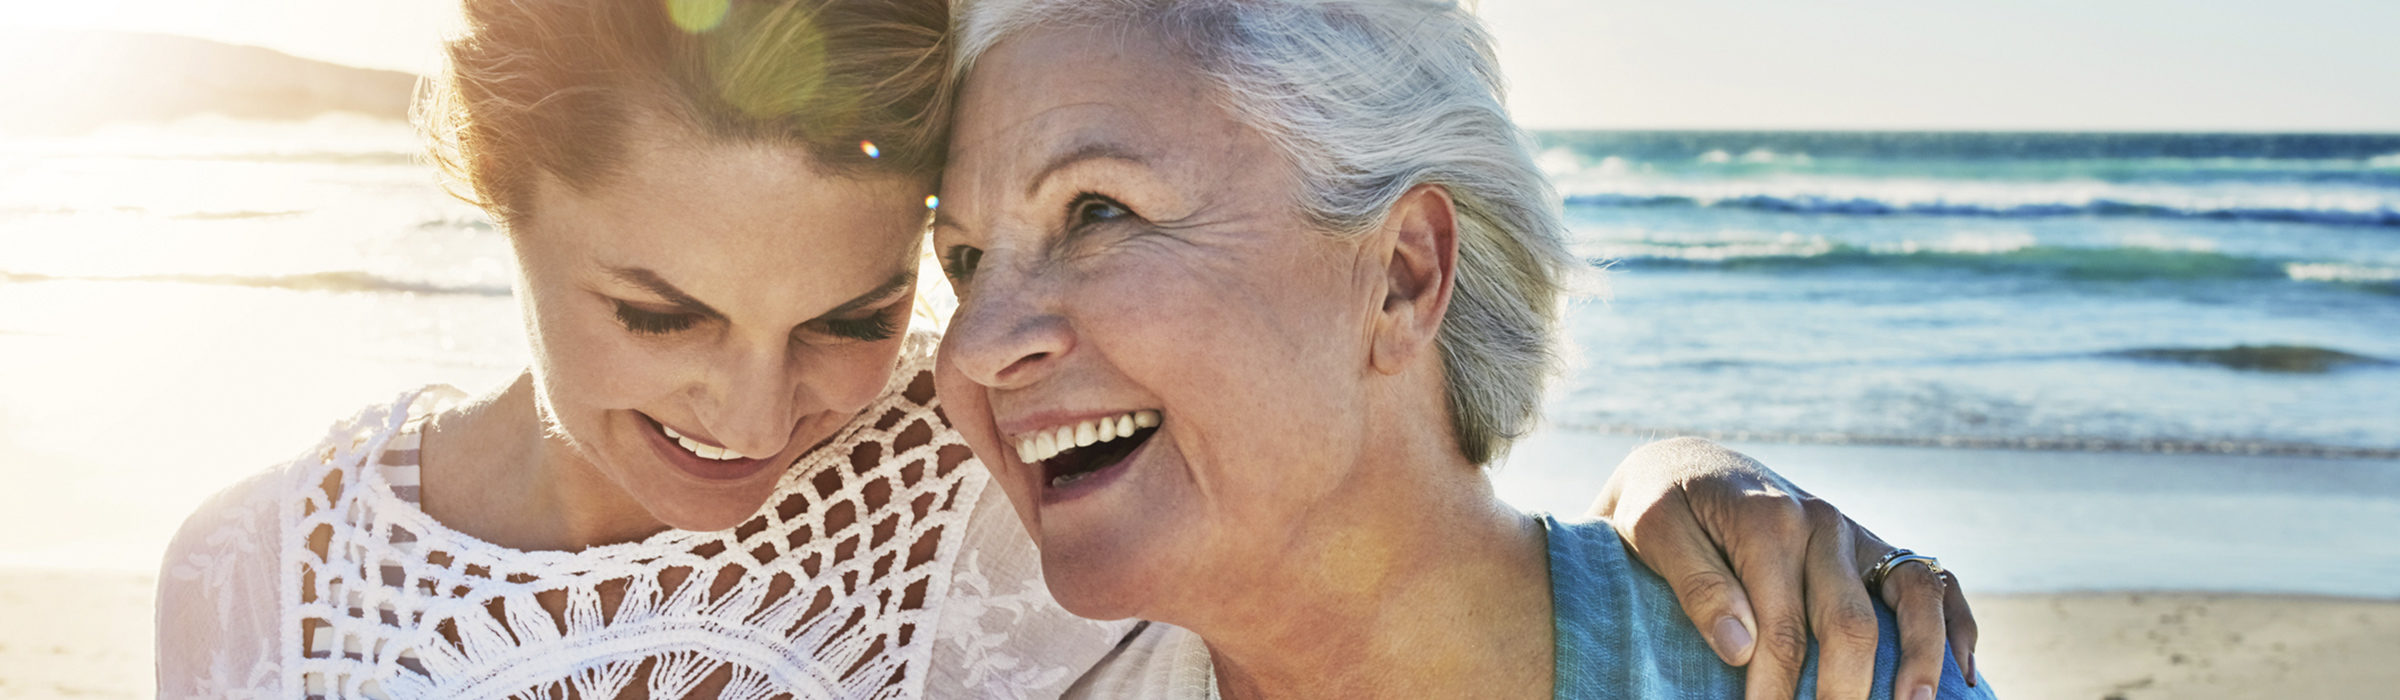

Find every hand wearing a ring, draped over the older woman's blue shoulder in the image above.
[1591,439,1975,698]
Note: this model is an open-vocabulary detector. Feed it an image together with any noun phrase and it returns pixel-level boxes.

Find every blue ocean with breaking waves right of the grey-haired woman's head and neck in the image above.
[1541,132,2400,458]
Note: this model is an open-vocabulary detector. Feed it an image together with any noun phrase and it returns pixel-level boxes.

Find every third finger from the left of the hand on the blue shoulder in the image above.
[1802,499,1906,700]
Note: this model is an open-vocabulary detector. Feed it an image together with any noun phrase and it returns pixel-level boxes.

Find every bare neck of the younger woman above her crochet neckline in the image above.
[420,372,667,551]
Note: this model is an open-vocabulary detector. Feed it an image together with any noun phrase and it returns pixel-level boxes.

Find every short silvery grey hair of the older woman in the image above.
[958,0,1577,463]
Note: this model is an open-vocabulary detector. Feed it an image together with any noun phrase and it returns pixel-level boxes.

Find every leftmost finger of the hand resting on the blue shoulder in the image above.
[1620,484,1759,666]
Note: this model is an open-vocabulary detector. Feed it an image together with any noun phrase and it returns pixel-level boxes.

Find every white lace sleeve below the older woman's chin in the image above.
[924,465,1135,698]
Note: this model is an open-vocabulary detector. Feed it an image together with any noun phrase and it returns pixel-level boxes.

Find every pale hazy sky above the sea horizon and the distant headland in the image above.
[0,0,2400,132]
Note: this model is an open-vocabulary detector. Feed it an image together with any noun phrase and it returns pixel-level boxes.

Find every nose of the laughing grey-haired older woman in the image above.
[941,260,1075,388]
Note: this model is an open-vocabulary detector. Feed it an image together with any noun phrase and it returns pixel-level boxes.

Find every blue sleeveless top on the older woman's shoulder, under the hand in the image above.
[1541,515,1992,700]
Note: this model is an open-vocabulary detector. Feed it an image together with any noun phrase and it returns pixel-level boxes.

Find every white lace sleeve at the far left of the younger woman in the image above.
[156,462,290,698]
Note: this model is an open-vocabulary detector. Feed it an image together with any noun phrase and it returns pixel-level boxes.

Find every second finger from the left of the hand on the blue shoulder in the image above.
[1699,501,1807,700]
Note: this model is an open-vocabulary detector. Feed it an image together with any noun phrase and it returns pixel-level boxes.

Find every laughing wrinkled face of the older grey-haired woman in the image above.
[934,31,1380,618]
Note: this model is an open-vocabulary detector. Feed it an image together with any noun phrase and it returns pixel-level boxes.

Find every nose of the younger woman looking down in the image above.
[696,338,802,458]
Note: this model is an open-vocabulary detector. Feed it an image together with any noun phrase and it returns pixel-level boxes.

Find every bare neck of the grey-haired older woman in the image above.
[1186,419,1553,698]
